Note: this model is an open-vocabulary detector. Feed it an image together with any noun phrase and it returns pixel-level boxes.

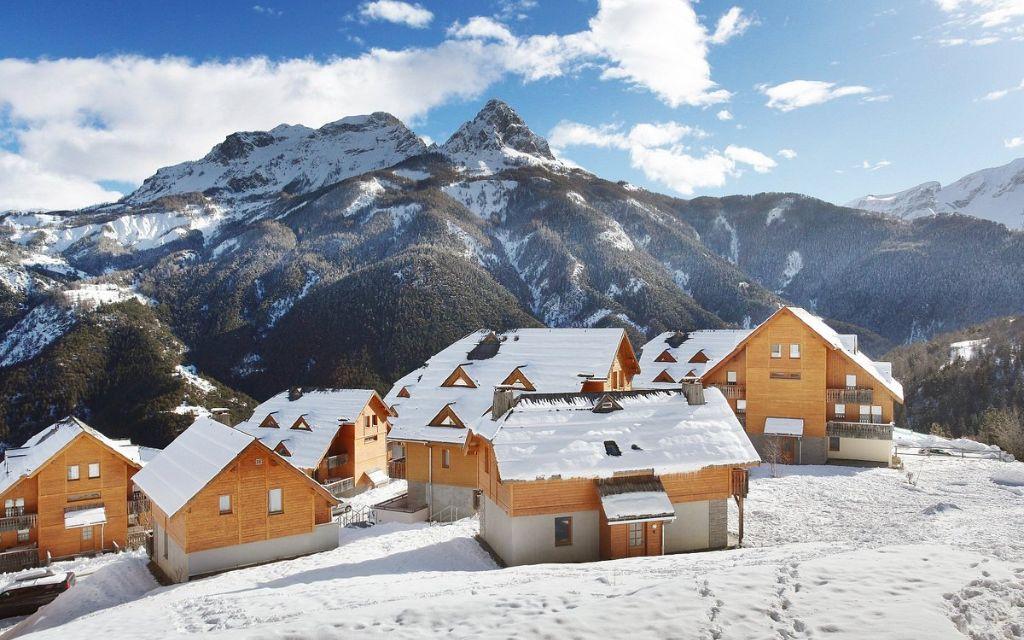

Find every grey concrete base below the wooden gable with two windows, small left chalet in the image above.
[187,522,339,578]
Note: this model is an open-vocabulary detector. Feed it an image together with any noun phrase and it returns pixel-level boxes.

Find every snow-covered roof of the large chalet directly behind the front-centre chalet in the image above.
[385,329,626,443]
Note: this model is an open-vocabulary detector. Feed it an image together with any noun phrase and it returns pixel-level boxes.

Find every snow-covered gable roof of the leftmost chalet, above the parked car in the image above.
[0,416,147,494]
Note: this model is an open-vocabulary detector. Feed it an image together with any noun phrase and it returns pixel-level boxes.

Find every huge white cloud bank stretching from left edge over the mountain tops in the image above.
[0,0,745,206]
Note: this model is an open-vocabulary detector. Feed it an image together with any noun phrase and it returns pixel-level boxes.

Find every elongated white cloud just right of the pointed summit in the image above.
[549,121,776,196]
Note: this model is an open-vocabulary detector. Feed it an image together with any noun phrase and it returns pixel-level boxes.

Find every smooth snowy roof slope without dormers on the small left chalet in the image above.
[132,417,255,516]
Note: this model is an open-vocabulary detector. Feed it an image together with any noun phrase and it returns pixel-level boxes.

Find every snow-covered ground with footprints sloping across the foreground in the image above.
[8,457,1024,640]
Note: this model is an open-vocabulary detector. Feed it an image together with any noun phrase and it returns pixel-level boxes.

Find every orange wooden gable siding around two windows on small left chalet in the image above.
[180,442,331,553]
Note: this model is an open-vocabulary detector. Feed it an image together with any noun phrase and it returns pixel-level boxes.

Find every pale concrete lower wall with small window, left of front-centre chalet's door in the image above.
[480,496,601,566]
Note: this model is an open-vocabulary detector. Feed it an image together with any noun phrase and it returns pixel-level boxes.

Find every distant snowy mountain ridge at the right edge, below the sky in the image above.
[847,158,1024,229]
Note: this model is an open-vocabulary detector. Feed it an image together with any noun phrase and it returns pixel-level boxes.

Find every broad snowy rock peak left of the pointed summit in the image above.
[126,112,426,205]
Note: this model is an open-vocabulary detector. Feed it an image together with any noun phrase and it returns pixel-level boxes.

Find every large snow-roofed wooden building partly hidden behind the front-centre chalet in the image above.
[385,329,639,517]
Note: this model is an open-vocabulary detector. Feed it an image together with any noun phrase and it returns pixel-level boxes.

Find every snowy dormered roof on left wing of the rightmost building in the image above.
[633,329,751,389]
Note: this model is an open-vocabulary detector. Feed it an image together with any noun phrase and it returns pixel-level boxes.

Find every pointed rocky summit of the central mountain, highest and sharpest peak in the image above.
[440,99,561,173]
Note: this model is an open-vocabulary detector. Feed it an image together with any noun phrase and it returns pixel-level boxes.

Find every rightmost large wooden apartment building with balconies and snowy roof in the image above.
[637,307,903,464]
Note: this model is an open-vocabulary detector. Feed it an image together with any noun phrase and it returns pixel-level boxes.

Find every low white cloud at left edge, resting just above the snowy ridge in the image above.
[0,151,121,211]
